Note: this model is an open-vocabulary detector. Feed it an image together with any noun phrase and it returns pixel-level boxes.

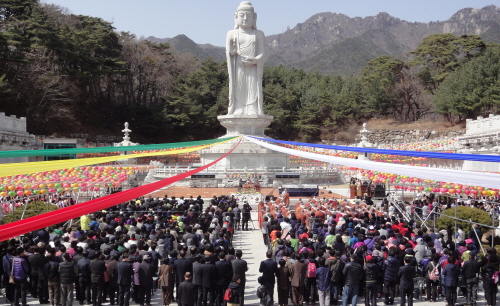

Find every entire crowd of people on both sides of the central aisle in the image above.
[0,189,500,306]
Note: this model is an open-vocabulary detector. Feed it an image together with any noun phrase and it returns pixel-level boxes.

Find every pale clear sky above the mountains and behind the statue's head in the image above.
[41,0,498,46]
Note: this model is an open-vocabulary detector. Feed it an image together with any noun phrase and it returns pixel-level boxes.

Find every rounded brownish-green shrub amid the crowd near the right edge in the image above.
[437,206,491,234]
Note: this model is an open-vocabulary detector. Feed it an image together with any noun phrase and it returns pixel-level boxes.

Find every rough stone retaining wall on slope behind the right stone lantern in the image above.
[356,129,465,145]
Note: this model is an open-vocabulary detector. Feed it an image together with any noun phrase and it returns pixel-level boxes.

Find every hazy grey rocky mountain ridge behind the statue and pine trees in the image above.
[147,5,500,75]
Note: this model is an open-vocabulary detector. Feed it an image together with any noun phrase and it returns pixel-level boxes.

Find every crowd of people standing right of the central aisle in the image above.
[260,196,500,306]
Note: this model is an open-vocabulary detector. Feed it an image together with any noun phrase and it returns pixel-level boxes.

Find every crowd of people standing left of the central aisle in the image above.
[0,196,251,306]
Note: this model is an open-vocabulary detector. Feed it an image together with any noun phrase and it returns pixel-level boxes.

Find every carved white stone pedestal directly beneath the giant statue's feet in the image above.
[217,115,274,137]
